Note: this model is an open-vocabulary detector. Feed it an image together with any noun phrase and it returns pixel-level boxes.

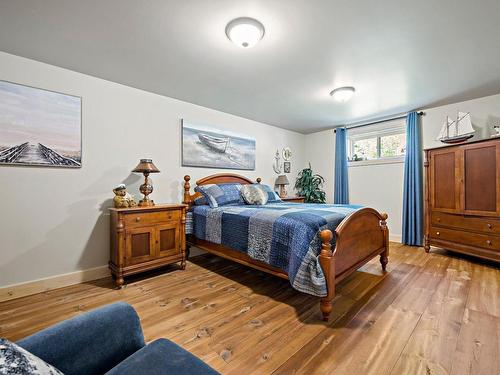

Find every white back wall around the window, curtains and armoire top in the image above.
[305,95,500,240]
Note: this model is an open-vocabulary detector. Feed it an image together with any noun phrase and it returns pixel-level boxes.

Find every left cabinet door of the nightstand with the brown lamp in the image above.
[125,227,156,266]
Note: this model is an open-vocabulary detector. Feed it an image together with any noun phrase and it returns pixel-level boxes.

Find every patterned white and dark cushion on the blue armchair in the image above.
[0,338,63,375]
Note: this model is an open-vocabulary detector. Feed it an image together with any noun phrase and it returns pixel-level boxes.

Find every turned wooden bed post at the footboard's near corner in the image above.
[319,229,335,322]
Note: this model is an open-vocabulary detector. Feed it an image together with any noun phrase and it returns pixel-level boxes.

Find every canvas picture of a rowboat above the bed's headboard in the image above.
[182,119,255,170]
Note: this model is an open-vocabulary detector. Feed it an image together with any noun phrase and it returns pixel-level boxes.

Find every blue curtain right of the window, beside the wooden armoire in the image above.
[402,112,424,246]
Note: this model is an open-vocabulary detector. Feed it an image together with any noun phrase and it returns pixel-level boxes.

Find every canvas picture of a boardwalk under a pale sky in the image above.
[0,81,82,168]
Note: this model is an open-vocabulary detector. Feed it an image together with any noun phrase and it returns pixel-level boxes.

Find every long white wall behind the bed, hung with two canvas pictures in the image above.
[0,53,305,286]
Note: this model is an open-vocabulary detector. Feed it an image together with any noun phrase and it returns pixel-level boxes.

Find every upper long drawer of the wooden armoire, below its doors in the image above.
[431,211,500,235]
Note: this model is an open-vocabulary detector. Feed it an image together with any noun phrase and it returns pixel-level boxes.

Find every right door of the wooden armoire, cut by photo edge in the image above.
[462,142,500,216]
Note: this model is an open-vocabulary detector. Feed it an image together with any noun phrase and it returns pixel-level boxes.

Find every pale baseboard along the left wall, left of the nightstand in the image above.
[0,266,110,302]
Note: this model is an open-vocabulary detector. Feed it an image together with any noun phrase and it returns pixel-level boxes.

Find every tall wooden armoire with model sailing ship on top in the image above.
[424,138,500,261]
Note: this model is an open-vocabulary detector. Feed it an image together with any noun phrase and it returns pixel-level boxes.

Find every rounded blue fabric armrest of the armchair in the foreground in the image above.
[17,302,145,375]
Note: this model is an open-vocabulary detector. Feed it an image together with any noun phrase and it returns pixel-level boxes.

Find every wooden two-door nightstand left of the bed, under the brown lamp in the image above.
[109,204,187,287]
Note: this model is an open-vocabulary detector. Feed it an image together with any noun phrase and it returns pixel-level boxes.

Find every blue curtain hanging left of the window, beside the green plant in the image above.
[333,128,349,204]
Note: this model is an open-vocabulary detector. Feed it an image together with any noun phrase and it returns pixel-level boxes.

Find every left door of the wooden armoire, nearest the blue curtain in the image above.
[429,147,462,213]
